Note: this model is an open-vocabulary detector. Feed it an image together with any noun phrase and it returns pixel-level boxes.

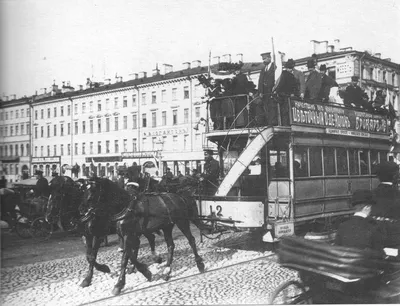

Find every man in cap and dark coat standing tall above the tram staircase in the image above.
[256,52,278,125]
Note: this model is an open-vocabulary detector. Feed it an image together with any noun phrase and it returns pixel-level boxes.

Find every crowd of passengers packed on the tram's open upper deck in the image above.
[199,52,395,130]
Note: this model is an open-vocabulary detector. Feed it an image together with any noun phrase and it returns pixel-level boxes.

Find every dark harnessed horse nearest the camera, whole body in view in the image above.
[87,179,204,295]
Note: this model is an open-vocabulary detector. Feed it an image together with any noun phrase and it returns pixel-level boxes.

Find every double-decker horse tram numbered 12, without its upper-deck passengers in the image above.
[197,97,390,241]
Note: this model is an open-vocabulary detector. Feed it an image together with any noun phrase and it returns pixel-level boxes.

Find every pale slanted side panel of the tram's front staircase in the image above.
[215,127,274,196]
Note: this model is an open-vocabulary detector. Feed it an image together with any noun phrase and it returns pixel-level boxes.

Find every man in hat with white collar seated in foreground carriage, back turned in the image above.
[335,190,384,252]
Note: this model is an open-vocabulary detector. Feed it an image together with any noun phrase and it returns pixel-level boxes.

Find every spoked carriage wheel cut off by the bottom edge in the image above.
[269,281,312,305]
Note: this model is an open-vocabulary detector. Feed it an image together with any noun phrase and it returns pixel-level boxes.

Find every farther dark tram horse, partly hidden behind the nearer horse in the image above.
[46,176,161,287]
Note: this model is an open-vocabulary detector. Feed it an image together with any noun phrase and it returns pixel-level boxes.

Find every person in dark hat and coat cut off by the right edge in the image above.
[371,161,400,248]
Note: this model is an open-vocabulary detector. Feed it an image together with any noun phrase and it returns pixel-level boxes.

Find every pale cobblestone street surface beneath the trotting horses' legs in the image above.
[1,226,296,305]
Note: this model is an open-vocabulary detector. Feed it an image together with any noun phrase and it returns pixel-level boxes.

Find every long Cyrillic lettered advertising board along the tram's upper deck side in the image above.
[290,100,388,137]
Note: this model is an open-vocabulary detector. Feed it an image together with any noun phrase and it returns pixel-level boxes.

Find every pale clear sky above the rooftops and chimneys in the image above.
[0,0,400,98]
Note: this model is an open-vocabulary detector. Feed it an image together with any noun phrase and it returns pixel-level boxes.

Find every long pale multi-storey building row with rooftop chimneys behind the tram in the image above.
[0,41,400,181]
